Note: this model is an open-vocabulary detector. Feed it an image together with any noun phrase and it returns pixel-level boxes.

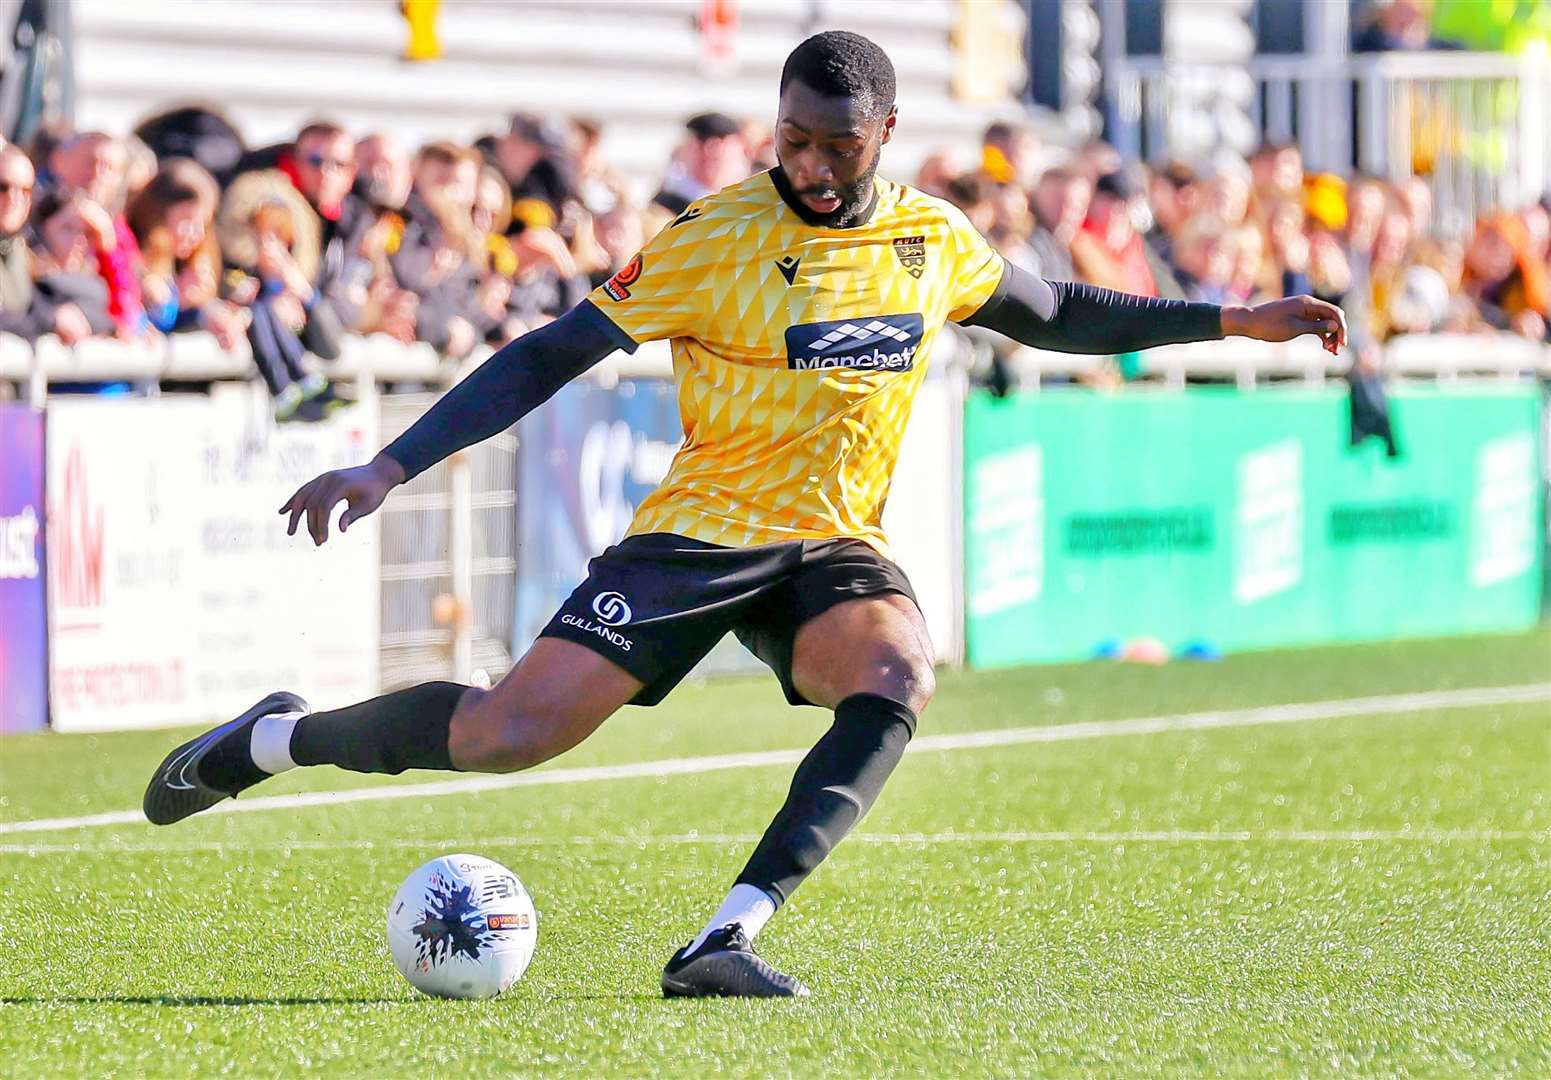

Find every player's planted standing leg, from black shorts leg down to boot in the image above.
[662,545,935,996]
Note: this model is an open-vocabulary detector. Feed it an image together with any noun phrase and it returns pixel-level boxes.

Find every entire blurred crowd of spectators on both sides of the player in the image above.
[0,109,1551,421]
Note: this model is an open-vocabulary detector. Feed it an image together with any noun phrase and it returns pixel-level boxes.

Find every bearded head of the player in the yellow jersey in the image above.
[776,29,895,227]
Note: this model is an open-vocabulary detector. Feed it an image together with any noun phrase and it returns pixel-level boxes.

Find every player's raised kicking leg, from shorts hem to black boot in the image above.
[144,638,642,824]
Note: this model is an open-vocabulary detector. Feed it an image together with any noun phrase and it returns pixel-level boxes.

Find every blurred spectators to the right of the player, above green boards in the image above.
[917,126,1551,360]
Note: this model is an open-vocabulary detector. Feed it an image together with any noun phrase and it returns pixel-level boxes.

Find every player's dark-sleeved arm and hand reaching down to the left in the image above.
[281,301,636,545]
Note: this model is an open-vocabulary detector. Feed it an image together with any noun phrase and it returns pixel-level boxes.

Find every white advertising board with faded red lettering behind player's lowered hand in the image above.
[48,388,378,731]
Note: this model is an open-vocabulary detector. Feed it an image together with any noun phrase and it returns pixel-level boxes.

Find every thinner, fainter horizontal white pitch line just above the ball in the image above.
[0,829,1551,855]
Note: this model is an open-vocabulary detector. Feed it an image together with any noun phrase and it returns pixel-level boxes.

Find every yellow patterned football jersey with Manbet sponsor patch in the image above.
[591,172,1003,556]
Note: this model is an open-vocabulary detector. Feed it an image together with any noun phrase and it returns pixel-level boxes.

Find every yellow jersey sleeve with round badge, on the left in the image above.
[588,214,707,344]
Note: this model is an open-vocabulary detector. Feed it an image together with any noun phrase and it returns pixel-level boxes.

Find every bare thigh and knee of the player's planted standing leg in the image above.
[791,593,937,714]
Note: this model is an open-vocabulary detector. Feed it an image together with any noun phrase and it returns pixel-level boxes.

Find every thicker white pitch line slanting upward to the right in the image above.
[0,683,1551,835]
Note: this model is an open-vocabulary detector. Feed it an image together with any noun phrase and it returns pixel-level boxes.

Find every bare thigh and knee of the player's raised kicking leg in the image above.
[451,638,642,771]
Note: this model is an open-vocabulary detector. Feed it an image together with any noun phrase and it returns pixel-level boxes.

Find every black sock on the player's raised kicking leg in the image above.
[290,683,468,773]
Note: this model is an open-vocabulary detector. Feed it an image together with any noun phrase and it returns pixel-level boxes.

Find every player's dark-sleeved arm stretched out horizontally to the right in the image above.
[963,264,1346,352]
